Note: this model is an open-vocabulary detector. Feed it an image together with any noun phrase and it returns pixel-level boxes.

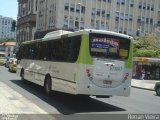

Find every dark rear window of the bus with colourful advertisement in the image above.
[90,33,130,60]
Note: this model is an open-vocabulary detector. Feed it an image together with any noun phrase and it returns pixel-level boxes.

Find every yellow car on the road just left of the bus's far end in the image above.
[8,58,17,72]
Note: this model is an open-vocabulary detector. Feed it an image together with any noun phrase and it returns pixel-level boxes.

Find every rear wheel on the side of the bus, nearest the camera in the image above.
[44,77,52,95]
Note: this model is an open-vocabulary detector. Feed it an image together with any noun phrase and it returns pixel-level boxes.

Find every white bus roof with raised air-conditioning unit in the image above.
[22,29,133,44]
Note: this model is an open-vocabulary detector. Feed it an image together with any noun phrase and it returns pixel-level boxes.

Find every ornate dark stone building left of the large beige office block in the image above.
[17,0,38,45]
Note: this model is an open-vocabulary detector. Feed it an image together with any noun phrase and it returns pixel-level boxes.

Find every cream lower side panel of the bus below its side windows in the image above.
[17,59,78,94]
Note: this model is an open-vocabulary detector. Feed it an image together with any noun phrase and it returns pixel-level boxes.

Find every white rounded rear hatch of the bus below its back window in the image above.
[92,59,124,88]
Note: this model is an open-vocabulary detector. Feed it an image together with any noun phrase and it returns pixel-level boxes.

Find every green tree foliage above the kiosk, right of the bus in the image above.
[134,34,160,58]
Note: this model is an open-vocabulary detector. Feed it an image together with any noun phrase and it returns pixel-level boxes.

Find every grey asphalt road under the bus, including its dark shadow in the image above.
[0,66,160,115]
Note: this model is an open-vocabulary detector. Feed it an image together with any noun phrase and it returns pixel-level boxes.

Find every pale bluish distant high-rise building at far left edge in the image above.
[0,16,16,39]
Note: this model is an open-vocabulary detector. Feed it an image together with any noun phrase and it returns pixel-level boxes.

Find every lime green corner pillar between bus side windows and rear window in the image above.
[76,34,93,64]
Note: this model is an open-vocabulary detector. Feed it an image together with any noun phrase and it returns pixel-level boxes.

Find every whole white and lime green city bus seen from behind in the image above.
[17,29,133,97]
